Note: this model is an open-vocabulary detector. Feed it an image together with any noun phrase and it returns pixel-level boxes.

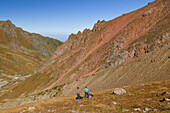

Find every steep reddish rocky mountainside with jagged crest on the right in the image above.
[2,0,170,99]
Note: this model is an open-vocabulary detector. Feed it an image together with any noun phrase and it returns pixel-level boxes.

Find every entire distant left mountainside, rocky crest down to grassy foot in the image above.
[0,20,62,75]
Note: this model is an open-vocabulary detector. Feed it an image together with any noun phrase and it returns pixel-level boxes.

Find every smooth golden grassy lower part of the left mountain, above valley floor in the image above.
[0,47,41,75]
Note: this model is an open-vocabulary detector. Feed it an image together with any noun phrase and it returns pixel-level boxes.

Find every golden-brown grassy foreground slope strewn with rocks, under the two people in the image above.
[1,81,170,113]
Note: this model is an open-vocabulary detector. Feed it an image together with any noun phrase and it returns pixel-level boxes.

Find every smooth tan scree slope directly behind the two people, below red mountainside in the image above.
[62,44,170,96]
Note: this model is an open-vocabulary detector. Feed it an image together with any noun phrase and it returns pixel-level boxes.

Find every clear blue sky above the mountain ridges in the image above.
[0,0,154,41]
